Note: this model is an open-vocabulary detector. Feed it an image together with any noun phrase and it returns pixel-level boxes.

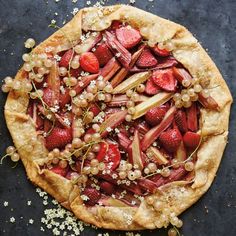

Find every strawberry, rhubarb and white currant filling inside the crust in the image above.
[9,21,218,207]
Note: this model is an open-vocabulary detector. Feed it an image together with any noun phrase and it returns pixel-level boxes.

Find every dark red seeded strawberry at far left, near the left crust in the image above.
[45,127,72,150]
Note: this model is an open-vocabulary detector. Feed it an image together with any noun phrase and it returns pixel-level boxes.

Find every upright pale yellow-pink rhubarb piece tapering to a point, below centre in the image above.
[128,130,144,170]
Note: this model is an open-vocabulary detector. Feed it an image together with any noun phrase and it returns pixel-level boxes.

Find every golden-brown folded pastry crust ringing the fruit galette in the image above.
[5,5,232,230]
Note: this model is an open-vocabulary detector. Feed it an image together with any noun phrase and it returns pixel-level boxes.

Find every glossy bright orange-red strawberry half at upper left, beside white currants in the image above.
[79,52,99,74]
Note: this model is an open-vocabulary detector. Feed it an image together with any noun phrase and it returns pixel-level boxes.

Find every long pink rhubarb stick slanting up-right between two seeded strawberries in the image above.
[141,107,176,151]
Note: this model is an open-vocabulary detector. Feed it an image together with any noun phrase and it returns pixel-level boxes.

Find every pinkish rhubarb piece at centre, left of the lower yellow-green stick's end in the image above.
[100,110,127,137]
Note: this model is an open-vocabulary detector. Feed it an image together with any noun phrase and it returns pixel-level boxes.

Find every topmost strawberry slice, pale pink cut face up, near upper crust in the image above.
[116,26,142,49]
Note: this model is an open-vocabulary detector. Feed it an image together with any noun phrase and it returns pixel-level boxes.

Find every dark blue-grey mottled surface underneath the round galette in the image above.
[0,0,236,236]
